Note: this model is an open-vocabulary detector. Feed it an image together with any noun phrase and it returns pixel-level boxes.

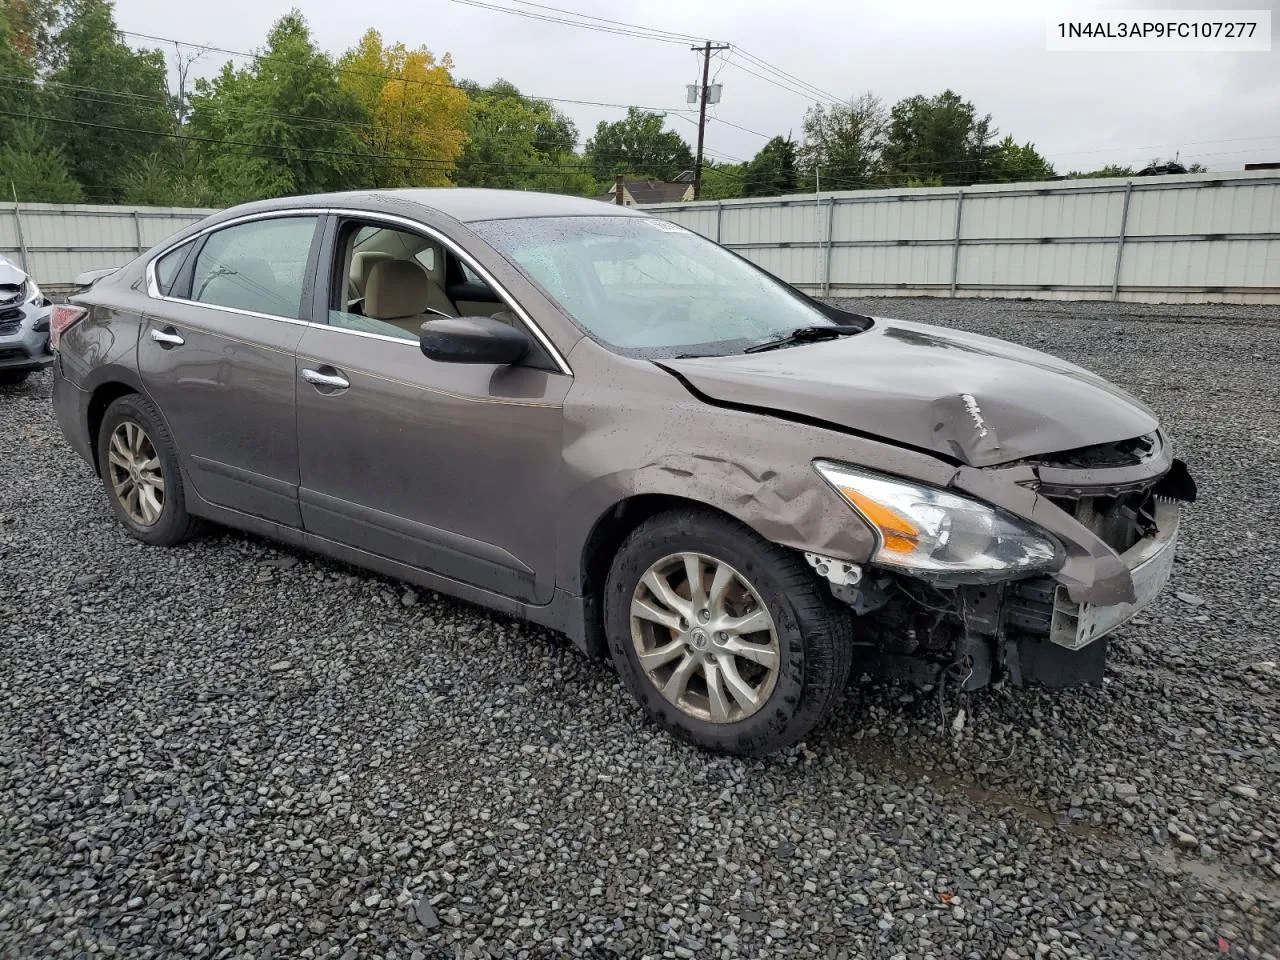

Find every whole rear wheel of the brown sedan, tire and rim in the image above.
[97,393,196,547]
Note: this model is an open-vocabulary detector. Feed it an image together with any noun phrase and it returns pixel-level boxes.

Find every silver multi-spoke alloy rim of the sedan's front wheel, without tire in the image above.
[631,553,781,723]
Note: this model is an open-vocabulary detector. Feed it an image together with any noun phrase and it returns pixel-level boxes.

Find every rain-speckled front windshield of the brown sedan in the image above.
[471,216,837,358]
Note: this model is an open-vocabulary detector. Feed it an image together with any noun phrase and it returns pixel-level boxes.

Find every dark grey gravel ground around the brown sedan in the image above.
[0,300,1280,960]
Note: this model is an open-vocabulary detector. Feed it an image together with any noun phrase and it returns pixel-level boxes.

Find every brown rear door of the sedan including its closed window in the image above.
[138,214,319,526]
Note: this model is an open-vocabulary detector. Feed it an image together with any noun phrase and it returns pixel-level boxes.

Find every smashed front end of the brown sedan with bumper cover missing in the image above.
[805,431,1196,690]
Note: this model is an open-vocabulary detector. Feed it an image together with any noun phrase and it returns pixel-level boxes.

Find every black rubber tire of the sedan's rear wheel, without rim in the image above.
[97,393,197,547]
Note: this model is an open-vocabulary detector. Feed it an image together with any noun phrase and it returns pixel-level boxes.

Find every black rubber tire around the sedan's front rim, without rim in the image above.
[604,508,852,756]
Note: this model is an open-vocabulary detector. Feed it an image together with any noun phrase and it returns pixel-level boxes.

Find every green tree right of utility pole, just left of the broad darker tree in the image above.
[797,93,887,189]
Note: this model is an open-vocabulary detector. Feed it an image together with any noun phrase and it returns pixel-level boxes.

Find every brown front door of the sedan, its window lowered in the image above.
[297,221,571,603]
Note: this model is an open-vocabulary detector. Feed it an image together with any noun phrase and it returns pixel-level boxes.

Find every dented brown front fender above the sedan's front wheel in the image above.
[557,340,951,594]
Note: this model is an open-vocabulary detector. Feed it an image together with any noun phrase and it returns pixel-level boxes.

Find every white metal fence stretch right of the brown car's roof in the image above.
[645,170,1280,303]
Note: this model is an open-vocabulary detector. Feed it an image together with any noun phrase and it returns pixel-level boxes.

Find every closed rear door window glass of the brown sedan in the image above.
[189,216,316,320]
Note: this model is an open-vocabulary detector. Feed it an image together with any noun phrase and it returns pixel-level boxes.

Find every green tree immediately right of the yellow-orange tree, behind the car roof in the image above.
[454,79,583,195]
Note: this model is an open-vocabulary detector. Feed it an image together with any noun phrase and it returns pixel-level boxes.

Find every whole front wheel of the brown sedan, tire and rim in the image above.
[604,509,852,755]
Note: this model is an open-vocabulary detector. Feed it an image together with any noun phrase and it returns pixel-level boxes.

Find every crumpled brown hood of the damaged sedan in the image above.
[662,317,1157,467]
